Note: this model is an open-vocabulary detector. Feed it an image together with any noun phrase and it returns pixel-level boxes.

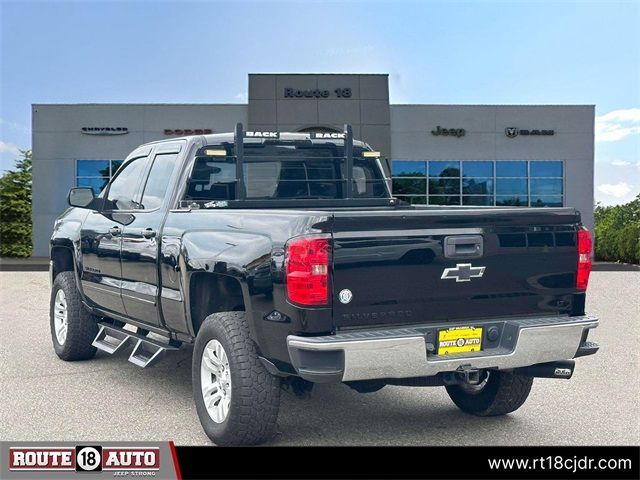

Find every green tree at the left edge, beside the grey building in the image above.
[0,150,32,257]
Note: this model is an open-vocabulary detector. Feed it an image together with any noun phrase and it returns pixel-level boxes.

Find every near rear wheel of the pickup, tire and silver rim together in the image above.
[192,312,280,445]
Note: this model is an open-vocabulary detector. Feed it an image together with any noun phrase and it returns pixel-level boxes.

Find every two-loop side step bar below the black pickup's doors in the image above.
[92,322,180,368]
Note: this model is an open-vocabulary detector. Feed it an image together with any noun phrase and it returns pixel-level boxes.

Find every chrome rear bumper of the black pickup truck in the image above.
[287,315,598,383]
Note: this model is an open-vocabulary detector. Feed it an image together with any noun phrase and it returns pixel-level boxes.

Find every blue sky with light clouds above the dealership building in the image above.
[0,0,640,204]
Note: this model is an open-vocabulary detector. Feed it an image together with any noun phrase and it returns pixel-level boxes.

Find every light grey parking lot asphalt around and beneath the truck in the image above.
[0,271,640,445]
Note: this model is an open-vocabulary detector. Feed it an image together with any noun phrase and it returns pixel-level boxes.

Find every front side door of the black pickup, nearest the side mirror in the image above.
[80,153,147,315]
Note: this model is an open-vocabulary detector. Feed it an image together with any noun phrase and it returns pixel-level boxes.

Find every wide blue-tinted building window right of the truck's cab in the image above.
[391,160,564,207]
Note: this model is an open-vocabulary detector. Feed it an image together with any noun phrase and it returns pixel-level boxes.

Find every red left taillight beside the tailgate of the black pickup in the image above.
[286,237,329,305]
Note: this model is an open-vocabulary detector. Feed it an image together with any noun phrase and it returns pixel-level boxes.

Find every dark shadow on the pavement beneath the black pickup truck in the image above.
[99,346,526,445]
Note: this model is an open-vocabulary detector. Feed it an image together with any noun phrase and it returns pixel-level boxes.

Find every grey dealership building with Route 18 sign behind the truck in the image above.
[32,74,594,256]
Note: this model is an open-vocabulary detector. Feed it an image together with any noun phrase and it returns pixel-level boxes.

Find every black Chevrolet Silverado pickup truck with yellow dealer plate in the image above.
[50,125,598,445]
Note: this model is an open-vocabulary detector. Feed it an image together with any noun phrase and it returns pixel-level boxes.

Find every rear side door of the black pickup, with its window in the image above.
[121,142,184,326]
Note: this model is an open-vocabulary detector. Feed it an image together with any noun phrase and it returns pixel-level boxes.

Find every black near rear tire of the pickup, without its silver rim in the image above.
[192,312,280,445]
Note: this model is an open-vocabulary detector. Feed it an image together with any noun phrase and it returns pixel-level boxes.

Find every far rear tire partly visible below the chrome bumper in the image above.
[446,370,533,417]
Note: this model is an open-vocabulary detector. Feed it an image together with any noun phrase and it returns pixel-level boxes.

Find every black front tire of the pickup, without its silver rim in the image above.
[49,272,98,362]
